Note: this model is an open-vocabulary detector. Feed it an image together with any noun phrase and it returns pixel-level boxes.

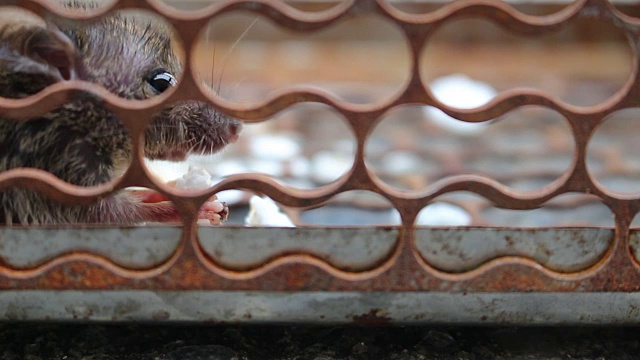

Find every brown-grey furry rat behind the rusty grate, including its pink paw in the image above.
[0,3,242,225]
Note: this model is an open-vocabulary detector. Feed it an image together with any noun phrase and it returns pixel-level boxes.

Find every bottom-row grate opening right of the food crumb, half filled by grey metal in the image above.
[415,193,614,273]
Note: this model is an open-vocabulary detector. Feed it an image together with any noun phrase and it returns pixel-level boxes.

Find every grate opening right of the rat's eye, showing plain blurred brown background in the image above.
[193,12,409,104]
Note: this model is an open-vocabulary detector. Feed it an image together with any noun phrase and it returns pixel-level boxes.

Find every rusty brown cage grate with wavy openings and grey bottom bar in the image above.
[0,0,640,323]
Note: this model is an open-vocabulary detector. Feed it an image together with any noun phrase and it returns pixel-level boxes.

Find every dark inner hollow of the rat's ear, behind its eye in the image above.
[23,23,79,80]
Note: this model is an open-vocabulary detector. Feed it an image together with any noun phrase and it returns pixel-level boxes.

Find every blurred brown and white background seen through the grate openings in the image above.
[142,0,640,227]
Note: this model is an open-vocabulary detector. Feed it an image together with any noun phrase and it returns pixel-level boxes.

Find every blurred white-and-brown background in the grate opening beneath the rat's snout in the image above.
[144,103,355,189]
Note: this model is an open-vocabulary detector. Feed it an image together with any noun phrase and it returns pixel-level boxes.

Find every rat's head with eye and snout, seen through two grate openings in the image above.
[31,9,242,160]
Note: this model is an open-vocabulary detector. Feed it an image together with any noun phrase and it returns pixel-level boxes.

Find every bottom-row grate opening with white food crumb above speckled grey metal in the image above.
[198,191,400,271]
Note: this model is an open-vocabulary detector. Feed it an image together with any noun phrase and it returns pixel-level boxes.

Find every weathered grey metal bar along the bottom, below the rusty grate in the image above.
[5,290,640,325]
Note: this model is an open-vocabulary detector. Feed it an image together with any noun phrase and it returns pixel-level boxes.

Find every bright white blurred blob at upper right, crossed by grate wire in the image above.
[424,74,498,135]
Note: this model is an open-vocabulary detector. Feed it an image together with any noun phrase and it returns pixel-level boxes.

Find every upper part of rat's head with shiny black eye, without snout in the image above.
[61,13,182,99]
